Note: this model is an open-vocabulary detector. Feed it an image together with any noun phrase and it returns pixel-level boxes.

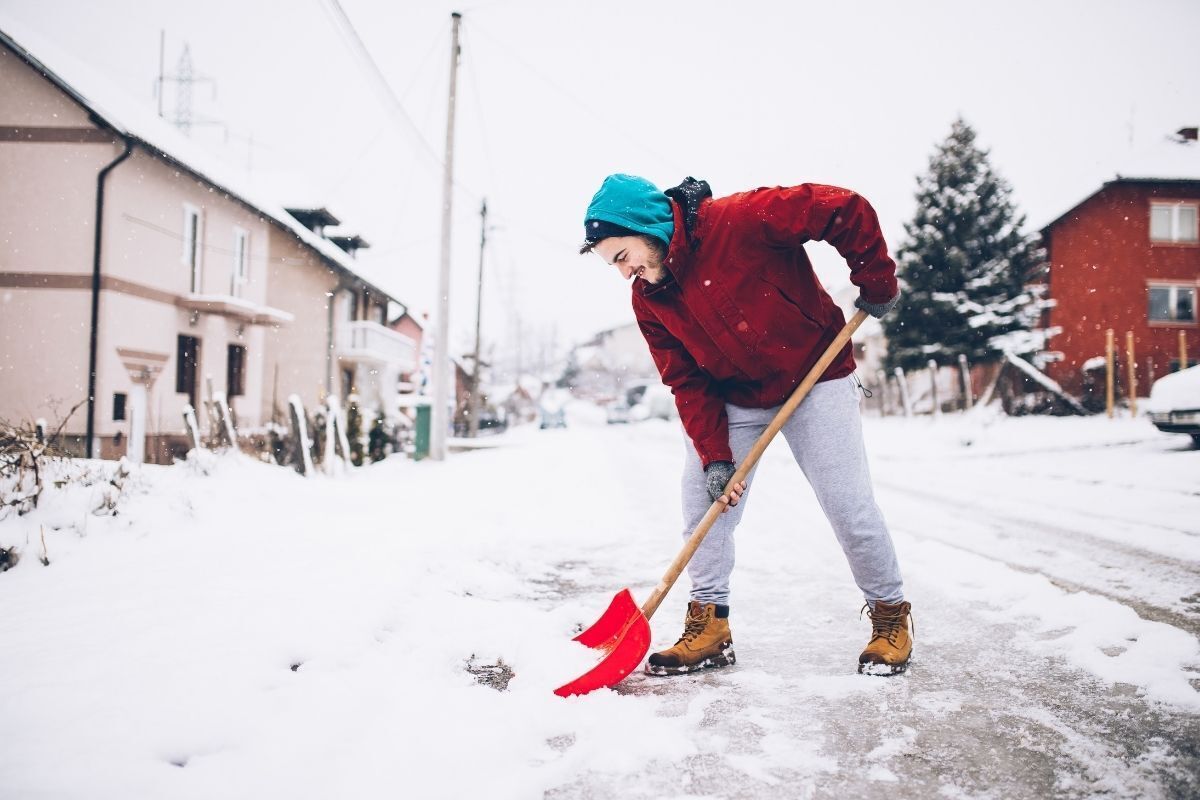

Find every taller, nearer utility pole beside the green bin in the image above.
[430,11,462,461]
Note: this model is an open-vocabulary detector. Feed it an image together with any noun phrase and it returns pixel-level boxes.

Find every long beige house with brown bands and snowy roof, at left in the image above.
[0,26,416,462]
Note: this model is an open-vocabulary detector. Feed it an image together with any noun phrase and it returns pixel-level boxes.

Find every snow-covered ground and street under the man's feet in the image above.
[0,403,1200,800]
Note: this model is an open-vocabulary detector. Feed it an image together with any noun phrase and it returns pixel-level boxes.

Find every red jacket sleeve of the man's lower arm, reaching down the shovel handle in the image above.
[634,300,733,467]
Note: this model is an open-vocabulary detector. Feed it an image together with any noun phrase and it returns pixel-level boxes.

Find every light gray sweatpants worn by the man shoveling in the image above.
[683,375,904,604]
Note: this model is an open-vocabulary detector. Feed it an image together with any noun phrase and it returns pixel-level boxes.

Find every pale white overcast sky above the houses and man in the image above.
[0,0,1200,369]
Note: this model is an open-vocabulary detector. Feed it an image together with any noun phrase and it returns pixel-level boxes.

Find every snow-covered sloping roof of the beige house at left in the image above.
[0,19,404,305]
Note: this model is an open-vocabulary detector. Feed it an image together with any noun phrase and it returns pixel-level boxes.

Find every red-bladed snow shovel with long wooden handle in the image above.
[554,311,866,697]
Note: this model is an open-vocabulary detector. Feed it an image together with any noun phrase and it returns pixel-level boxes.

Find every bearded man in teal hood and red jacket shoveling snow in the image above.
[580,175,912,675]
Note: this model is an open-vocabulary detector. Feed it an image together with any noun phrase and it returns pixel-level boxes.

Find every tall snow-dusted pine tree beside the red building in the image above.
[883,119,1045,369]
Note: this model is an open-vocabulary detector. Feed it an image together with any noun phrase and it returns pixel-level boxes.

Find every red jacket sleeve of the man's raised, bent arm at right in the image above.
[750,184,899,305]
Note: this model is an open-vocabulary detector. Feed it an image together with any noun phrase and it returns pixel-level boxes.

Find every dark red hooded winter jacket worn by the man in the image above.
[632,179,898,467]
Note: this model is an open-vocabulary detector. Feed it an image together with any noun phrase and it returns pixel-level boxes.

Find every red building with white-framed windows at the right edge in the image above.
[1042,178,1200,397]
